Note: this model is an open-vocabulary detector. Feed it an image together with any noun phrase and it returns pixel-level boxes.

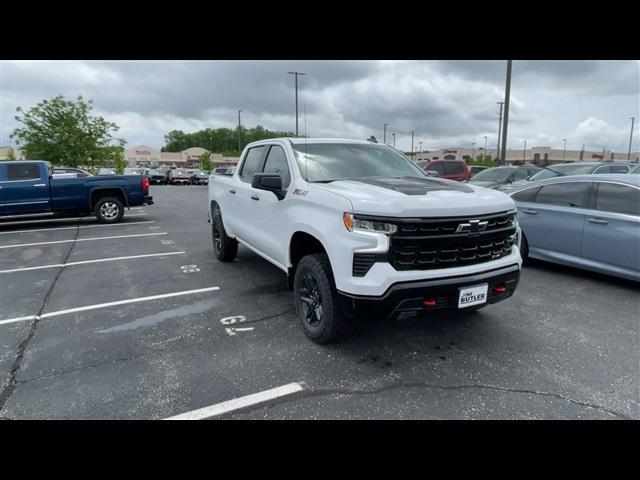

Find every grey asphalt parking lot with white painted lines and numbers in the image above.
[0,186,640,419]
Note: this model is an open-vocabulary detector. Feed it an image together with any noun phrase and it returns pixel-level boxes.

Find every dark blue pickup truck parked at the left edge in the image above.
[0,161,153,223]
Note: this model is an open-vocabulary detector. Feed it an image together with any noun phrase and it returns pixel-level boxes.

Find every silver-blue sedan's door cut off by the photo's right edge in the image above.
[582,182,640,275]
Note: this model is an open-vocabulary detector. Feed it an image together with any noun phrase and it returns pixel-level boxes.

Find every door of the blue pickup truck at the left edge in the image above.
[0,162,51,215]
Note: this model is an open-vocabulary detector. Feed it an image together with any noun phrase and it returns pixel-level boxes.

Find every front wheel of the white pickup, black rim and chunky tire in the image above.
[293,254,346,344]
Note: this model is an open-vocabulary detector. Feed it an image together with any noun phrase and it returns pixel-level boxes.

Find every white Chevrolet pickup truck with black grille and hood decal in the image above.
[209,138,522,343]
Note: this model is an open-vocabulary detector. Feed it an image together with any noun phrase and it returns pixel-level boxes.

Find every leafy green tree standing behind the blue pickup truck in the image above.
[11,95,124,167]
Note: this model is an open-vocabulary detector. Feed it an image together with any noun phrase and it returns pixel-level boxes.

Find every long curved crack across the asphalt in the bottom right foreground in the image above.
[218,382,632,420]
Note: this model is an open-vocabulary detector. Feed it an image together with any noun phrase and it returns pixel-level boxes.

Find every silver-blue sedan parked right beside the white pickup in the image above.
[509,174,640,281]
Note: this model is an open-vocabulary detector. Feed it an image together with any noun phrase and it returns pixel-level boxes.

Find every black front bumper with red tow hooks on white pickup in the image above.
[339,263,520,318]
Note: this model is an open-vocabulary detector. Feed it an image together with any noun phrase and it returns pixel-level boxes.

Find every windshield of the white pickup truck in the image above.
[293,143,424,182]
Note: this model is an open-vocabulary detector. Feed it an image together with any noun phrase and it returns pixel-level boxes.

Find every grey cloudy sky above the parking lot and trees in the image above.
[0,61,640,152]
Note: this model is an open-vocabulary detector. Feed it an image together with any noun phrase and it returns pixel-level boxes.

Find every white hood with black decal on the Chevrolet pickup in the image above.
[311,177,515,217]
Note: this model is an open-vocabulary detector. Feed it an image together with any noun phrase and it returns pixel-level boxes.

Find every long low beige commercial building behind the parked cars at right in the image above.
[413,147,640,165]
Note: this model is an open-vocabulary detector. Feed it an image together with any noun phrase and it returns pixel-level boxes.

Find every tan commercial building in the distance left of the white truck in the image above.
[124,145,239,168]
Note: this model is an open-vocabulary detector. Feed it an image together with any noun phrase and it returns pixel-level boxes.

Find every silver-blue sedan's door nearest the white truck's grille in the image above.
[514,182,589,261]
